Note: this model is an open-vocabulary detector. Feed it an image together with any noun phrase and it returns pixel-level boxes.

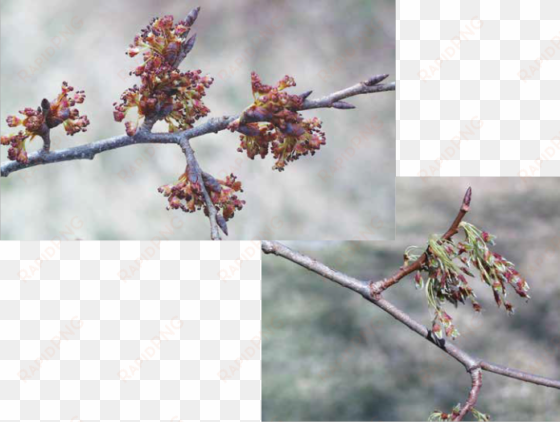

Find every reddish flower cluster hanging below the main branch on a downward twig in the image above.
[158,167,245,227]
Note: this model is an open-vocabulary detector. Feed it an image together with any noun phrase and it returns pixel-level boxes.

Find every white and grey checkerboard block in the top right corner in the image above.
[397,0,560,177]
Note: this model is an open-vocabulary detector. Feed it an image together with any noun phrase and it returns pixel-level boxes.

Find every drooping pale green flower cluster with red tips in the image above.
[405,222,529,339]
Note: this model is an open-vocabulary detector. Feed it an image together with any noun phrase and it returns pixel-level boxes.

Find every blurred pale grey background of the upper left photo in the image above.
[0,0,395,240]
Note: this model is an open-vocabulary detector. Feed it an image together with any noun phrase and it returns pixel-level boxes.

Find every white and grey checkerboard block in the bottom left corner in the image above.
[0,242,261,421]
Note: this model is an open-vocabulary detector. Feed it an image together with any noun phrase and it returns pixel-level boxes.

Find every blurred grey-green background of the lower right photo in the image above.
[262,178,560,421]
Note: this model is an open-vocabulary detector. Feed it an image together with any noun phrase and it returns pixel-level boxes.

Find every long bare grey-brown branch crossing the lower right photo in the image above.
[262,241,560,420]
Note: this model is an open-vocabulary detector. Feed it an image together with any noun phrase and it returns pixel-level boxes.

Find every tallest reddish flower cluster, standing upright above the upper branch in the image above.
[113,9,214,136]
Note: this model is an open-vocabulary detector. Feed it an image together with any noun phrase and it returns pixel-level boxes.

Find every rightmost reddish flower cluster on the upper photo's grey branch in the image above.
[229,72,326,171]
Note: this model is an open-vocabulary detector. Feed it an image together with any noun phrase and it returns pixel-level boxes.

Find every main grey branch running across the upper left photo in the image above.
[1,75,395,177]
